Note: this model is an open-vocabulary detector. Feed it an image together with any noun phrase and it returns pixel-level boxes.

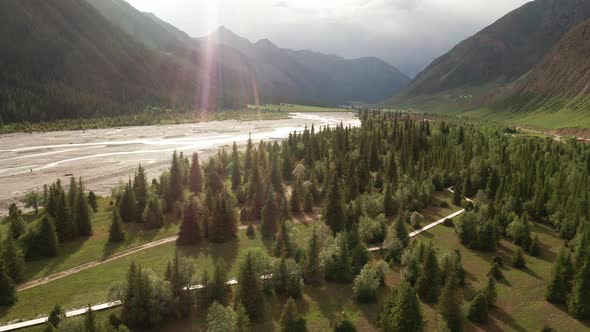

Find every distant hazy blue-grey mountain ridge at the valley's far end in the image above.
[204,27,410,104]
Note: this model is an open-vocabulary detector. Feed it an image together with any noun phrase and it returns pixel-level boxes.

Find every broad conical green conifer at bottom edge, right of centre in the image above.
[380,281,424,332]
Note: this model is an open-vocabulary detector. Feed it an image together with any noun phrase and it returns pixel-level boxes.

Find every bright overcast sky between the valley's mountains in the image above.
[127,0,528,76]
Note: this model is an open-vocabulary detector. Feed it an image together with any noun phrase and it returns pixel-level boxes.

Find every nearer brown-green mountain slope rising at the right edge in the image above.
[492,19,590,112]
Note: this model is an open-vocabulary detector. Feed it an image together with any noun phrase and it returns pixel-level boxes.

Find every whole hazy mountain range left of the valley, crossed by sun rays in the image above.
[0,0,410,122]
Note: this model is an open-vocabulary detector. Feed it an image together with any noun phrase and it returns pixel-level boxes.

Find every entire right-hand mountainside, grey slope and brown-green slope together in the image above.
[384,0,590,125]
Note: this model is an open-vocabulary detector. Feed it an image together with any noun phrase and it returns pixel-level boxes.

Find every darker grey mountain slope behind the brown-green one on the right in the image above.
[389,0,590,104]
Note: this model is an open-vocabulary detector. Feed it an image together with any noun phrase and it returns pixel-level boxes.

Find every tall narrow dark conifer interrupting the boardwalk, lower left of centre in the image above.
[238,251,264,320]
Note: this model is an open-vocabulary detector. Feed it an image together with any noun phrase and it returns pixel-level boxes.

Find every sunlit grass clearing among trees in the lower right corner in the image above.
[418,220,589,331]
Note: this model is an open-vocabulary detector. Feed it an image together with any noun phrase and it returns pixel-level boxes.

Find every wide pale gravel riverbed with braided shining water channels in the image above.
[0,112,360,214]
